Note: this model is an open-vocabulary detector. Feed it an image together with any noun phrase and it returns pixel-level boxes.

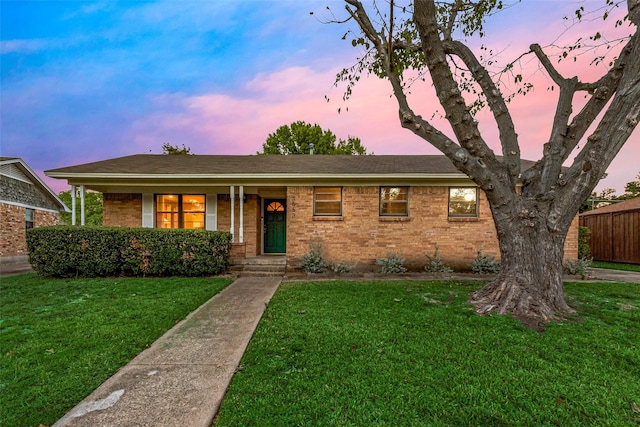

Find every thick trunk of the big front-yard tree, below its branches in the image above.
[469,207,573,325]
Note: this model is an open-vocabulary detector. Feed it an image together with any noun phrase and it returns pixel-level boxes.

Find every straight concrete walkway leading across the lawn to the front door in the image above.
[54,277,281,427]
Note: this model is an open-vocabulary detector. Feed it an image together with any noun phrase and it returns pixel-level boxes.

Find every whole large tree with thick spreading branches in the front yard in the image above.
[338,0,640,321]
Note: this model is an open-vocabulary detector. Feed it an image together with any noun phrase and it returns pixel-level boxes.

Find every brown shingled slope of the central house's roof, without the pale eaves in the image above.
[45,154,533,178]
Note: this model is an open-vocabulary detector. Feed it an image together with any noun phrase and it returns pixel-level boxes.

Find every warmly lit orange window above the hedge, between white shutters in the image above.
[156,194,205,230]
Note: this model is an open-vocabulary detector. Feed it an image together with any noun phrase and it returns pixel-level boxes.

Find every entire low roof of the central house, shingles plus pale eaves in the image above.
[45,154,533,192]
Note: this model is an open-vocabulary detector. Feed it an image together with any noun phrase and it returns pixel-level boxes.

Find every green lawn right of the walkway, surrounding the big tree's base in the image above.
[215,281,640,427]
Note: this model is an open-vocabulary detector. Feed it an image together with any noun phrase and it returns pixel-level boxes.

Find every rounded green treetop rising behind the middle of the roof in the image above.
[257,121,367,155]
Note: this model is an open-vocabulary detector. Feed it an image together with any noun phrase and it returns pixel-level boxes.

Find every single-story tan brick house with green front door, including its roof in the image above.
[45,155,577,268]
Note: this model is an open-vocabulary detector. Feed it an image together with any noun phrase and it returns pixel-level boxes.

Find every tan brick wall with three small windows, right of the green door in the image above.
[287,186,577,268]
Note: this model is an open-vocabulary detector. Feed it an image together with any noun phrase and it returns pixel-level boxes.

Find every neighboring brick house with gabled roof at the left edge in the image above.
[0,157,69,262]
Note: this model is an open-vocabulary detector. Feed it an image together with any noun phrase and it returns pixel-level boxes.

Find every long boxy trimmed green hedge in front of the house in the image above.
[27,226,231,277]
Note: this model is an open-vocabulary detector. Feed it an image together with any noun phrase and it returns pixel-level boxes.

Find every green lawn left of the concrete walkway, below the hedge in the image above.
[0,274,230,426]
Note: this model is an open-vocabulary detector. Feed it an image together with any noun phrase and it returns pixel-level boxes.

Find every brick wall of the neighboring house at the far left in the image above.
[0,202,60,257]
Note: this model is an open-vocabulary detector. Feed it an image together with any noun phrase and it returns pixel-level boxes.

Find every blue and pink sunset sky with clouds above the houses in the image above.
[0,0,640,194]
